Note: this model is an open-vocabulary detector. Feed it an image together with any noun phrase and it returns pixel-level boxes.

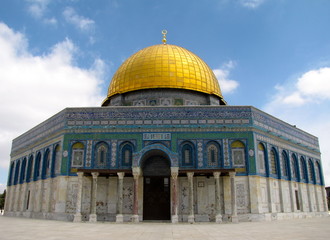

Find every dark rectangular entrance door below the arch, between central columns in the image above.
[143,177,171,220]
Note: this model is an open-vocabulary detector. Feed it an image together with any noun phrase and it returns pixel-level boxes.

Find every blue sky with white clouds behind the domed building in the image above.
[0,0,330,192]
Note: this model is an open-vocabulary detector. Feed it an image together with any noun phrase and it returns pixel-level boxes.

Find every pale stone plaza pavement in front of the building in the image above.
[0,216,330,240]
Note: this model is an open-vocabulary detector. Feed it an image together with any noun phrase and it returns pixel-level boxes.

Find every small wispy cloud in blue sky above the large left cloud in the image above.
[63,7,95,32]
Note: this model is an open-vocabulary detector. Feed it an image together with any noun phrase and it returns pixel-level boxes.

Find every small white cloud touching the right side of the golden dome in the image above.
[213,61,239,93]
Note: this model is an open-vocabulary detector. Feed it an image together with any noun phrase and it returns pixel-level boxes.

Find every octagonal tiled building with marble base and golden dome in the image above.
[5,36,327,223]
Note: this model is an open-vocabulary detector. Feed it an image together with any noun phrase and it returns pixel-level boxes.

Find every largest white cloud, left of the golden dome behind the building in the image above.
[0,22,105,186]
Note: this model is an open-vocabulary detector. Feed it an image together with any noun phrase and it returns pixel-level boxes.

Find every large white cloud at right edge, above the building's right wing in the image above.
[263,67,330,185]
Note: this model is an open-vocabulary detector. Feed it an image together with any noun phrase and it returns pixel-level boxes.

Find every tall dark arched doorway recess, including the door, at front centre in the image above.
[141,150,171,220]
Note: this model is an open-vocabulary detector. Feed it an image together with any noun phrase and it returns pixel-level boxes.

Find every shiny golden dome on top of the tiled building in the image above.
[103,44,223,103]
